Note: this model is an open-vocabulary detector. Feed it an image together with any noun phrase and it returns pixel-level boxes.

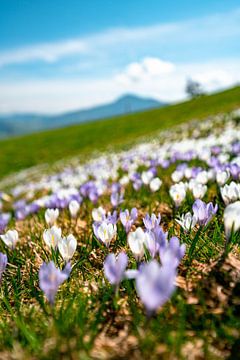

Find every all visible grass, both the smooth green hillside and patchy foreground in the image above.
[0,88,240,360]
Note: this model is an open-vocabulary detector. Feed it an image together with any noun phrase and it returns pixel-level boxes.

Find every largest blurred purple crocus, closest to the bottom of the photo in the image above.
[136,260,176,315]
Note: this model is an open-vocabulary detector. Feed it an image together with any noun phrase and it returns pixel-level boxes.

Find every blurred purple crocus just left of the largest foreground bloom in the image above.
[104,252,128,286]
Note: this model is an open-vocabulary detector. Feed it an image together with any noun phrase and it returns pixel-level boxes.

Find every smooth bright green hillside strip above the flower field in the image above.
[0,87,240,178]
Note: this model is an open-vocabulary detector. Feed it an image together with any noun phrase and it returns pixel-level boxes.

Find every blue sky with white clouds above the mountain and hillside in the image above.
[0,0,240,114]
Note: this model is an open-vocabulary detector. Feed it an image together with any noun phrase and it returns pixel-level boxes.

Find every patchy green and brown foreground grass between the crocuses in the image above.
[0,158,240,359]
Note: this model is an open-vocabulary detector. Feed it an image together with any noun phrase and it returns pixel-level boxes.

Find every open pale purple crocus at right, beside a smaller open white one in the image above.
[192,199,218,225]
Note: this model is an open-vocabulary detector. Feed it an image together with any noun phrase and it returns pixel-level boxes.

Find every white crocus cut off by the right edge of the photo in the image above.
[223,201,240,238]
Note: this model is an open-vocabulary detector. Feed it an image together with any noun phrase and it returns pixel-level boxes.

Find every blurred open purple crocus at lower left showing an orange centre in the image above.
[39,261,71,305]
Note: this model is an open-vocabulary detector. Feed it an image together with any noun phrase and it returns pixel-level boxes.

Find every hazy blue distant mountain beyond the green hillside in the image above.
[0,95,167,138]
